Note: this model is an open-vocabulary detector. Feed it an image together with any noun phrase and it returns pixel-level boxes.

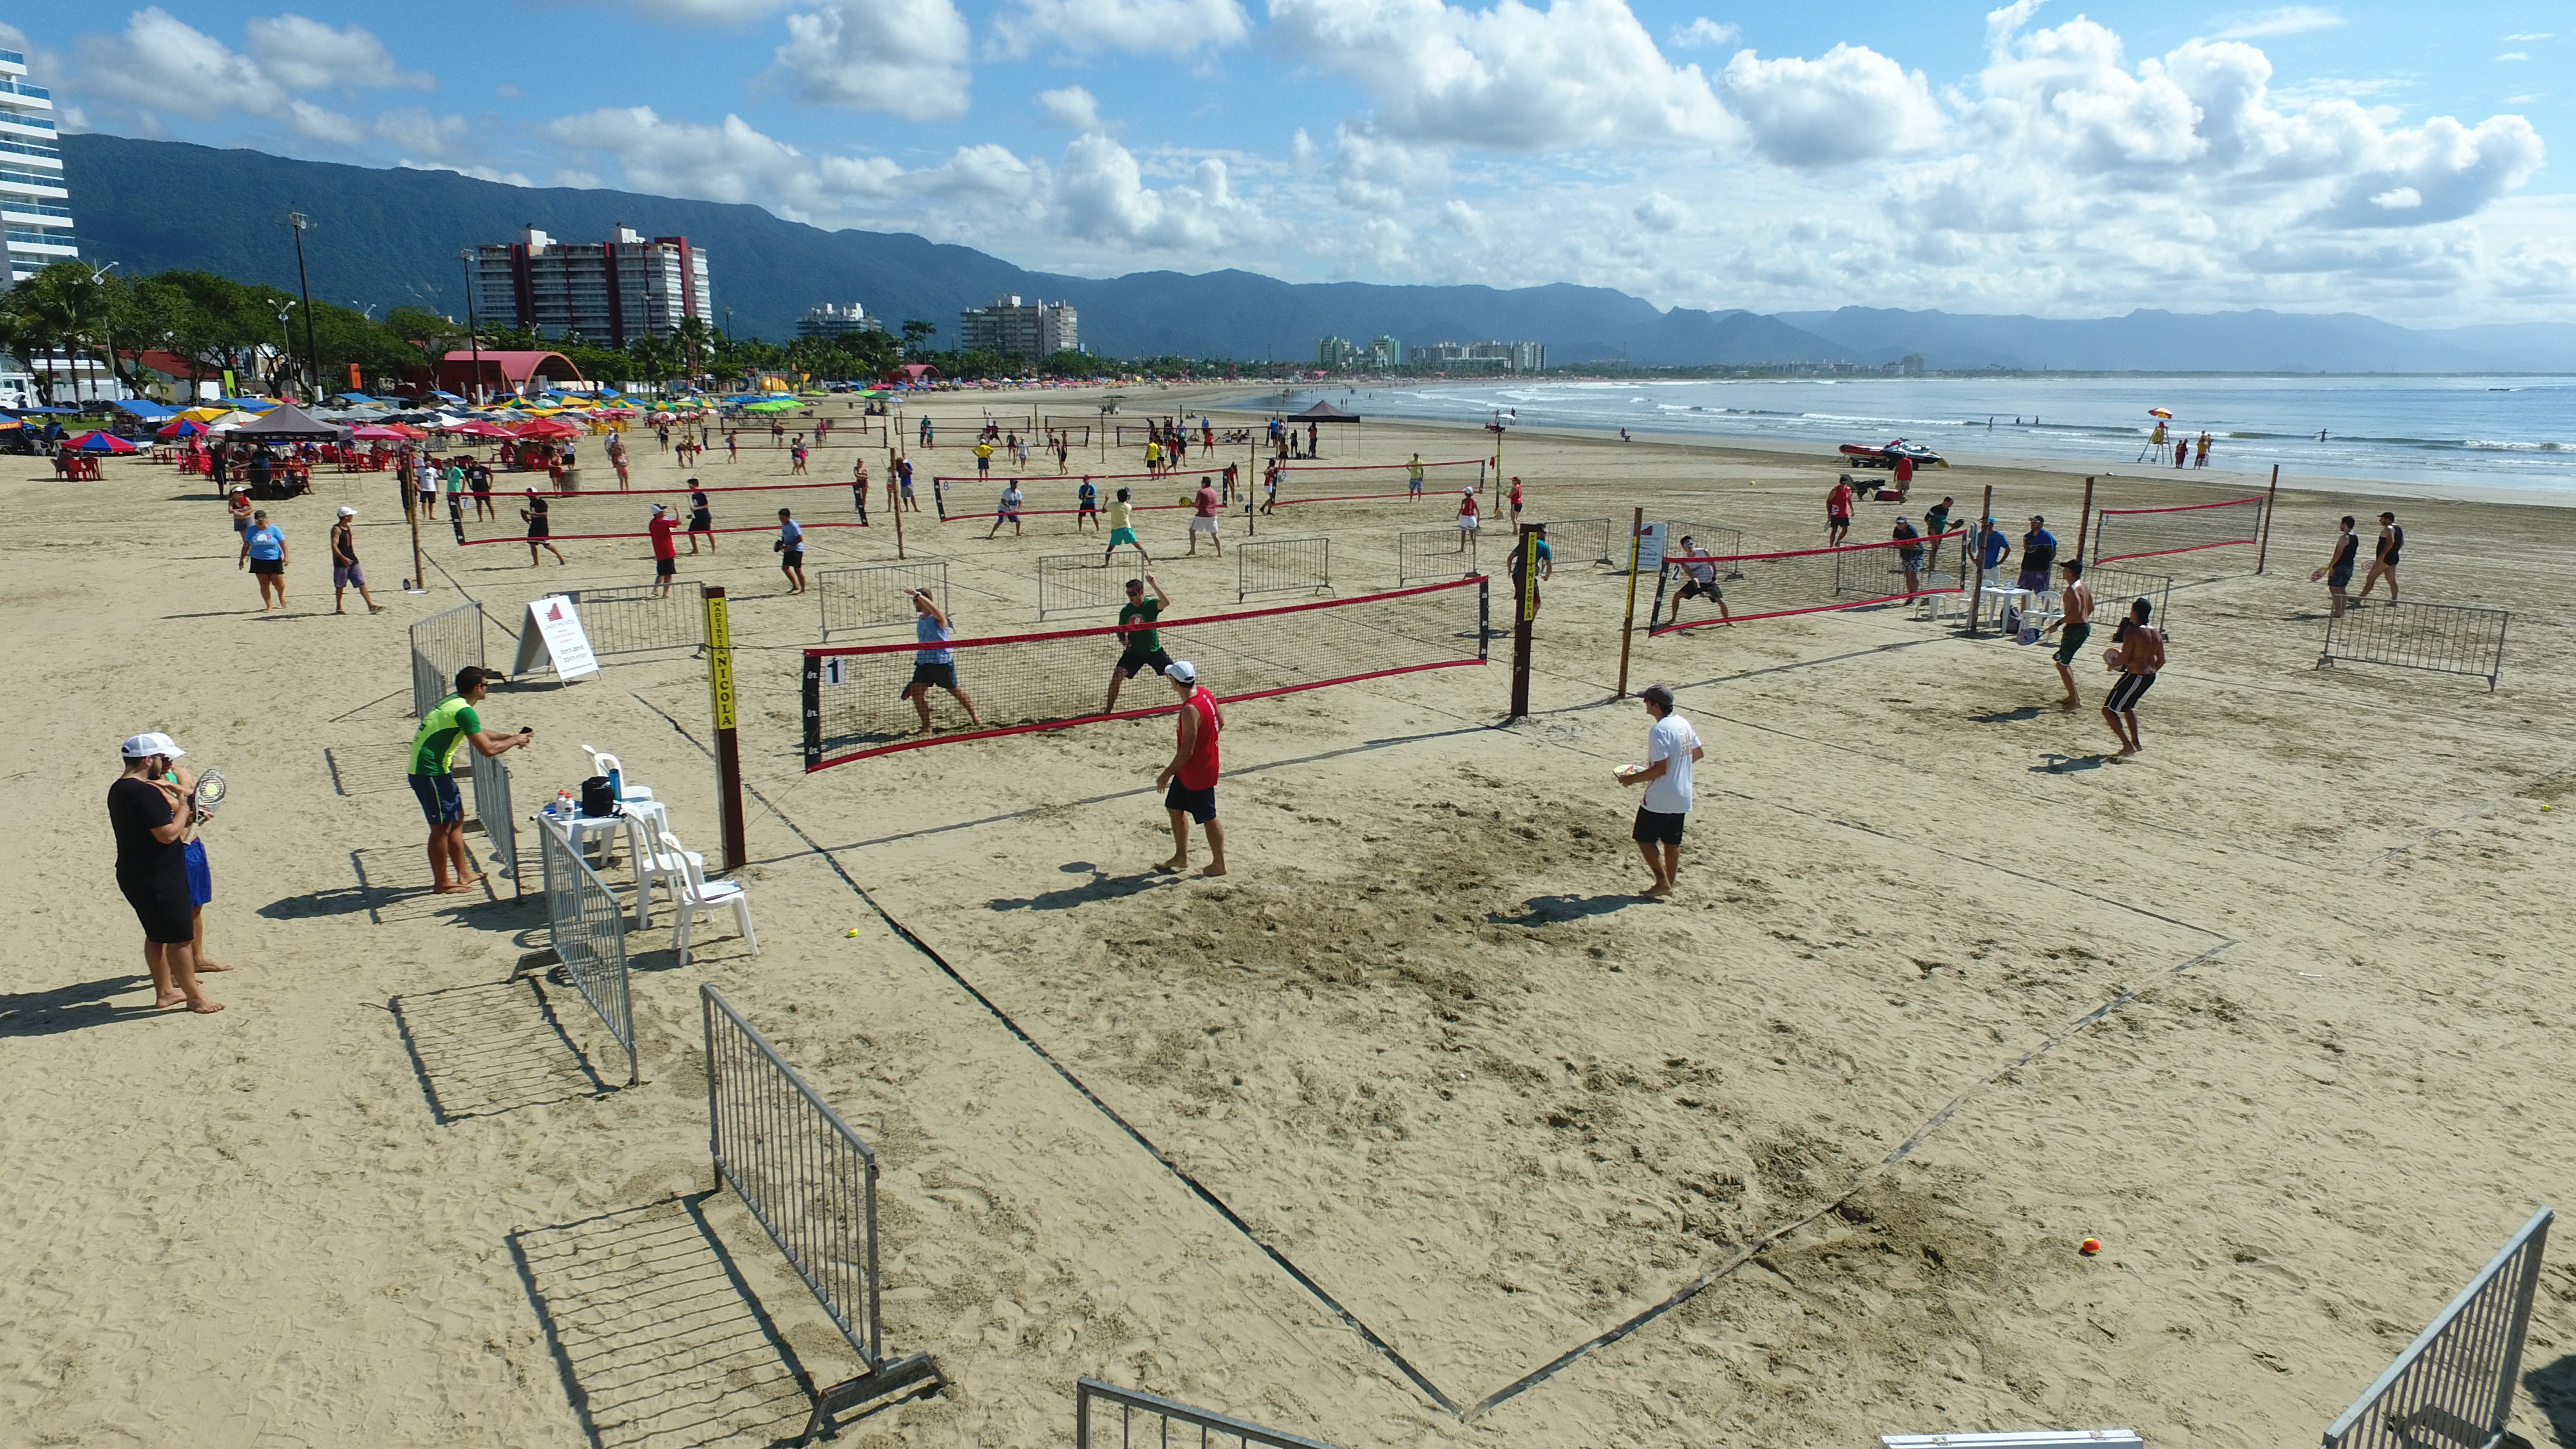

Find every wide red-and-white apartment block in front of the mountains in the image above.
[474,227,716,348]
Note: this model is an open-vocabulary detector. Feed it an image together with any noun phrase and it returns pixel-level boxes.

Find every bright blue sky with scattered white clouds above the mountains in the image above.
[18,0,2576,325]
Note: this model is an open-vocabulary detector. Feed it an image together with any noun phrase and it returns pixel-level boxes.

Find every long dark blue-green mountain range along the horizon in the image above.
[62,134,2576,372]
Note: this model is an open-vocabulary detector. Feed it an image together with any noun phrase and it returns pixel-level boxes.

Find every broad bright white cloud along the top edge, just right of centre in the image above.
[1270,0,1736,149]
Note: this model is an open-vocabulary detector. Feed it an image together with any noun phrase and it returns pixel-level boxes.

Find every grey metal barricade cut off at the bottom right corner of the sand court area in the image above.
[2324,1207,2555,1449]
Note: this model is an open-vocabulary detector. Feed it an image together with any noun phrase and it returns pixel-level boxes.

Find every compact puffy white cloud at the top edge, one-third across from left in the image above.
[765,0,971,121]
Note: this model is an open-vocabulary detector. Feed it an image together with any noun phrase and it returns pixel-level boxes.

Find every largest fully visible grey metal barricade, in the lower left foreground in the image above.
[698,985,940,1436]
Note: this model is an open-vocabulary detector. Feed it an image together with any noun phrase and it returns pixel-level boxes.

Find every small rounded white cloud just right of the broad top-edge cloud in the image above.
[1726,46,1942,165]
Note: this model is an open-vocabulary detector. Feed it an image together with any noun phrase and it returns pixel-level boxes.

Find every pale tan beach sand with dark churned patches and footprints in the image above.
[0,390,2576,1449]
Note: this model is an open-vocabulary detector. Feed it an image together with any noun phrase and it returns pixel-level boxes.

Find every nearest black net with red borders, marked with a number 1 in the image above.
[804,575,1486,771]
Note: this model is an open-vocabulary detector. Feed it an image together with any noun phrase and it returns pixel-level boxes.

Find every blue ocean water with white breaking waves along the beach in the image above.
[1247,377,2576,498]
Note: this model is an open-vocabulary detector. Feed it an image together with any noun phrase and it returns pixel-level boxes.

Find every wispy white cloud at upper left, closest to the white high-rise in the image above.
[70,5,433,147]
